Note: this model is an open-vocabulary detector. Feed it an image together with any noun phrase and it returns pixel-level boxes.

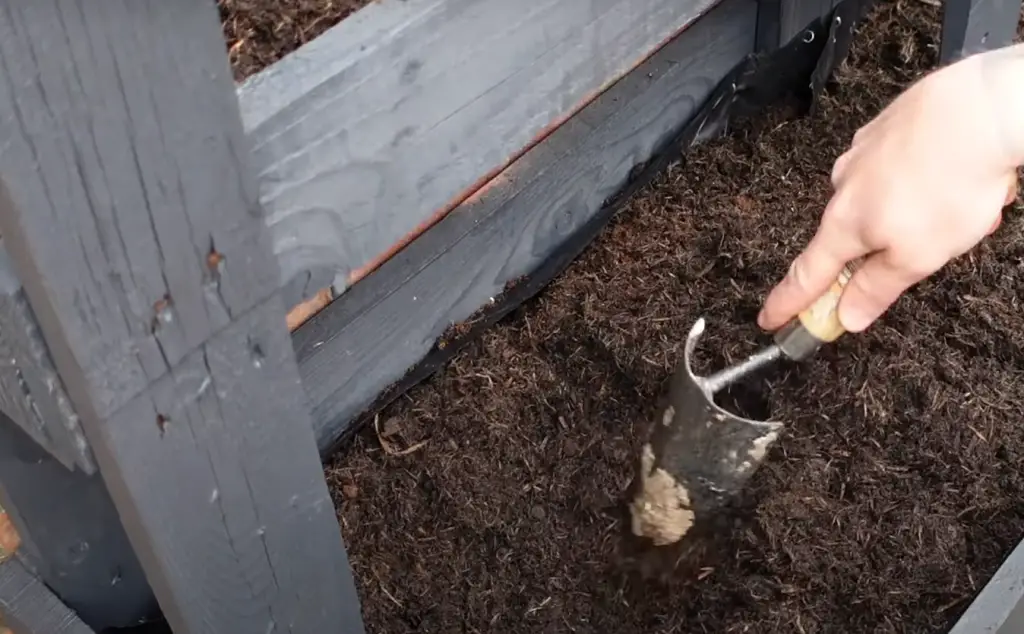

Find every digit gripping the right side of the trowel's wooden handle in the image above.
[839,250,941,333]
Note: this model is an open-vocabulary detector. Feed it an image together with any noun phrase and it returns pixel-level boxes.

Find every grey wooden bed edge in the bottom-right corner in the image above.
[949,542,1024,634]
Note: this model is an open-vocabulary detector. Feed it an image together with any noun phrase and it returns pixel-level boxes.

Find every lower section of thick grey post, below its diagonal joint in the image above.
[97,298,361,634]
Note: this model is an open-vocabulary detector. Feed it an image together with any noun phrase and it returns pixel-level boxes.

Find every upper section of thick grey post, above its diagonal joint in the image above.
[0,0,278,424]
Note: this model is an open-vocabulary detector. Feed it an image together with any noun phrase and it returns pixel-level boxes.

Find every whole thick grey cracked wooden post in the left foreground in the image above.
[0,0,362,634]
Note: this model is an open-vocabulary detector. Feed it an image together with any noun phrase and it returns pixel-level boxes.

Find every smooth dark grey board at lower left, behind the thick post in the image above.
[0,416,159,631]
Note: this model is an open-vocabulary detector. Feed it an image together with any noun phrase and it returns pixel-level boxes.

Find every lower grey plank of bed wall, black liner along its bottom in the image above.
[293,2,864,455]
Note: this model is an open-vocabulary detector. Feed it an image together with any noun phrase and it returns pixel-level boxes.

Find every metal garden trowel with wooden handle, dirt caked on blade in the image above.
[630,259,859,546]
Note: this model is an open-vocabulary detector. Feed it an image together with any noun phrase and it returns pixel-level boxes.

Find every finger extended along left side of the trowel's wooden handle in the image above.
[758,216,866,331]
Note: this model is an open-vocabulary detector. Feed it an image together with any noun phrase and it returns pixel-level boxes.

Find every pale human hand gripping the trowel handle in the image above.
[758,48,1024,332]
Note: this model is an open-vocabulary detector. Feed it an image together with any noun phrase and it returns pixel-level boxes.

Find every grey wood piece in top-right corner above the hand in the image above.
[939,0,1021,64]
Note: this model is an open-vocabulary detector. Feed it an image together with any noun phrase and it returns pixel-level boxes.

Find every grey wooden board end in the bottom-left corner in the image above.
[0,559,93,634]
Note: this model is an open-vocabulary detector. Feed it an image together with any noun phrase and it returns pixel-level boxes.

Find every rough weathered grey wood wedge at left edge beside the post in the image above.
[0,239,96,473]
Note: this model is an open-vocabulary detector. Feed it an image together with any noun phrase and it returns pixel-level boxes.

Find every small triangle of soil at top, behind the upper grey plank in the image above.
[217,0,374,81]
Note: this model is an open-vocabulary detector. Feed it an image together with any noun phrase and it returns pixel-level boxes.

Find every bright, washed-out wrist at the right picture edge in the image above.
[965,44,1024,169]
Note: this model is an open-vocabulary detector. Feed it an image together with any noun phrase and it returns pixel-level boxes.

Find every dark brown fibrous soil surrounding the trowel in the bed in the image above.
[325,0,1024,634]
